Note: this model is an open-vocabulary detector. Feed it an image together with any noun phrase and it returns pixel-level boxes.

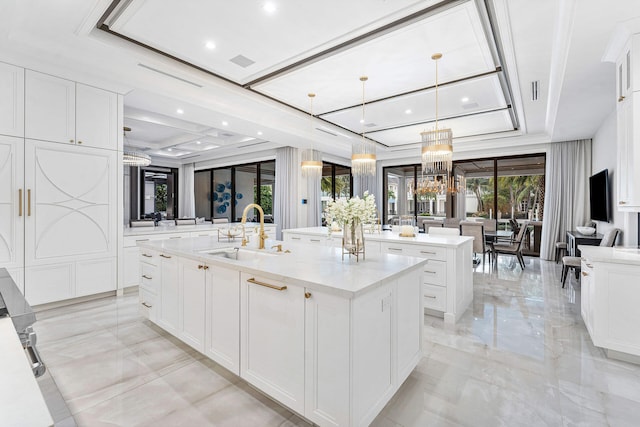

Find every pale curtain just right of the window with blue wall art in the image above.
[273,147,300,240]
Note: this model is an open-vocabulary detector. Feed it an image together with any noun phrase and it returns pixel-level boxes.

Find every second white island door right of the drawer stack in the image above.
[178,258,209,353]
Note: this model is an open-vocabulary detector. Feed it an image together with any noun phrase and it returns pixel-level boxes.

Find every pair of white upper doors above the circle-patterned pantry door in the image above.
[25,70,119,150]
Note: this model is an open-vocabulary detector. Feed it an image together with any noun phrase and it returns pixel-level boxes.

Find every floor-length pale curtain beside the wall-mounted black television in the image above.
[540,139,591,260]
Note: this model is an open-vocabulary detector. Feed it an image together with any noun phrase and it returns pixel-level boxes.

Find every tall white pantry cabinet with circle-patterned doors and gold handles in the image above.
[0,63,122,305]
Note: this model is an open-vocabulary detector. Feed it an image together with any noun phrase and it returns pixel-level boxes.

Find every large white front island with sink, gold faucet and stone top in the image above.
[139,237,427,426]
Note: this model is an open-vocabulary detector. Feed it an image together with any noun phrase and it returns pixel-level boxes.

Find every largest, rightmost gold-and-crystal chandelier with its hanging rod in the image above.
[420,53,453,174]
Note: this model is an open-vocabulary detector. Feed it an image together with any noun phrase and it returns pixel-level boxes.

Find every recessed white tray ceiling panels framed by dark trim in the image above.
[99,0,518,153]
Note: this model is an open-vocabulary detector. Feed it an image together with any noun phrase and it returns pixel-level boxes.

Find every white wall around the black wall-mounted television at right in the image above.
[591,110,639,246]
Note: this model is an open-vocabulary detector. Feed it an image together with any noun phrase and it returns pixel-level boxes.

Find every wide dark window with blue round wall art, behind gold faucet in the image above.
[194,160,276,222]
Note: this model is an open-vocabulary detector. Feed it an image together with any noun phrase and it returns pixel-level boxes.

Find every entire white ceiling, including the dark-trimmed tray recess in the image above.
[0,0,640,166]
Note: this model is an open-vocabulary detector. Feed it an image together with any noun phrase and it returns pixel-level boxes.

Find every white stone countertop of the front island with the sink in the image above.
[138,237,427,298]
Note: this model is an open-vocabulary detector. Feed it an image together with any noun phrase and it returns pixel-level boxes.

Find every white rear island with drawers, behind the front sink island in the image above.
[282,227,473,323]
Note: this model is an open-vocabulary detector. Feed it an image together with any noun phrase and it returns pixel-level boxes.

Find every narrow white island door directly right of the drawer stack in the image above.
[156,253,180,336]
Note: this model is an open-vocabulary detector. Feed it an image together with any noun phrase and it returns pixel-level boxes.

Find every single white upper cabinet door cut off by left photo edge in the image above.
[0,62,24,137]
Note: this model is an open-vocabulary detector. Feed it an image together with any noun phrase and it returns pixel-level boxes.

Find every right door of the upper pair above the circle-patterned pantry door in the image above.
[76,83,118,150]
